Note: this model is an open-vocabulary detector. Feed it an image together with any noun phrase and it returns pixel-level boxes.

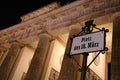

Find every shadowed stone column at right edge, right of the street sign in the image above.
[111,15,120,80]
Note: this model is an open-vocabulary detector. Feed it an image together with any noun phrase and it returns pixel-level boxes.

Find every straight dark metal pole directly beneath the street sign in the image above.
[80,53,88,80]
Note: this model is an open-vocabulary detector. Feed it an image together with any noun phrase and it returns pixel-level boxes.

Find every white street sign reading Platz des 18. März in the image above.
[70,31,105,55]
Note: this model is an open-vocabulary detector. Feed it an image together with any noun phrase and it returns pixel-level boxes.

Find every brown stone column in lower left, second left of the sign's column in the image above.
[0,43,21,80]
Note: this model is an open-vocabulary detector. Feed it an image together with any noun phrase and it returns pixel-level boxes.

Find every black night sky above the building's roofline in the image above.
[0,0,75,30]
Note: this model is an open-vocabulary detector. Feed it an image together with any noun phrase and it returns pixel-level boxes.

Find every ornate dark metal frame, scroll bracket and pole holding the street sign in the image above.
[67,20,109,80]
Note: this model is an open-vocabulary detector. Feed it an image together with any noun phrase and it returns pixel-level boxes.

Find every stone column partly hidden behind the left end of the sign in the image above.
[58,29,80,80]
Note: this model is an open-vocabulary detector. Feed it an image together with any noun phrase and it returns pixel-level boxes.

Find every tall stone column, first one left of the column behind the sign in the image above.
[25,34,50,80]
